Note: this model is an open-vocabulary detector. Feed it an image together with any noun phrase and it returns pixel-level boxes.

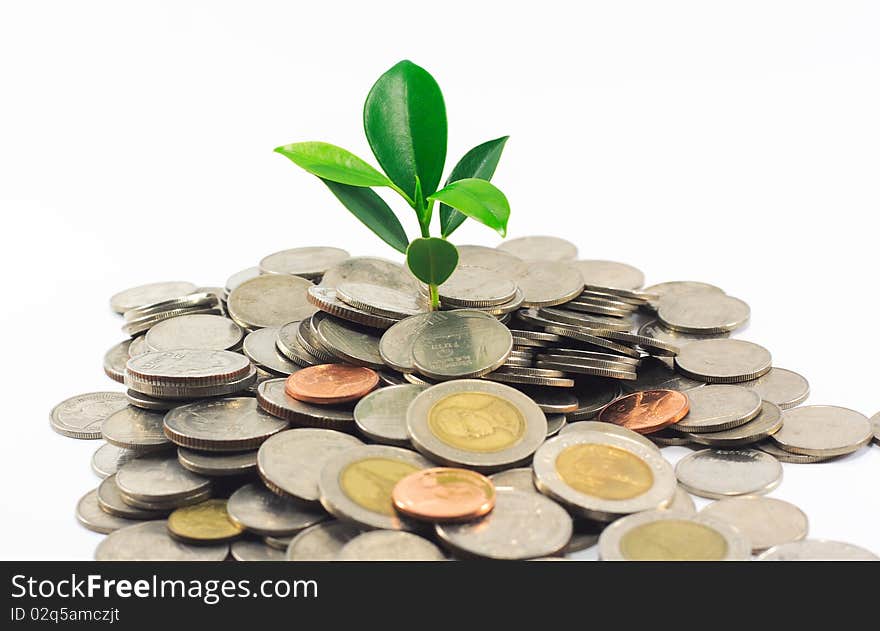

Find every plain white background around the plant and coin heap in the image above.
[0,0,880,559]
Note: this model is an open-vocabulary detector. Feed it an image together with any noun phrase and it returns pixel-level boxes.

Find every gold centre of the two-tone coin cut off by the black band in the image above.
[620,519,728,561]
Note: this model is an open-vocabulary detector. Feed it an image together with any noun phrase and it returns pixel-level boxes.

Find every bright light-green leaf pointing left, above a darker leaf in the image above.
[275,142,391,186]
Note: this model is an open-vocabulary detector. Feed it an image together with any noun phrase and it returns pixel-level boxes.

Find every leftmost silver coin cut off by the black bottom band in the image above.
[95,520,229,561]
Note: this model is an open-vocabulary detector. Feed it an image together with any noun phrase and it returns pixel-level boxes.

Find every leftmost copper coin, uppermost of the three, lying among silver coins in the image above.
[284,364,379,405]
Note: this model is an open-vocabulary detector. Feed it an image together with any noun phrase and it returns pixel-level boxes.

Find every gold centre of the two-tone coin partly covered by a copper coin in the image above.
[339,458,419,515]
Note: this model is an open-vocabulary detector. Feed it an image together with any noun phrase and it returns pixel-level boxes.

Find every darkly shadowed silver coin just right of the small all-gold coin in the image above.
[226,484,327,537]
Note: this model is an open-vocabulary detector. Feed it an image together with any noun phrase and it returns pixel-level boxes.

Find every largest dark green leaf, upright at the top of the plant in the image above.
[364,60,446,201]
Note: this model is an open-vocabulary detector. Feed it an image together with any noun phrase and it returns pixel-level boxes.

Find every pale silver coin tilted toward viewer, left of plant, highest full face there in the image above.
[227,274,316,329]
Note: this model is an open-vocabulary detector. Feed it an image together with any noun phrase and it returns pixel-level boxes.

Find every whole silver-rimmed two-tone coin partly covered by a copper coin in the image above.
[318,445,431,530]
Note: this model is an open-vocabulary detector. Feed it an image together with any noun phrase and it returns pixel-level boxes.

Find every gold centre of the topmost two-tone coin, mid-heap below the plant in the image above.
[428,392,526,453]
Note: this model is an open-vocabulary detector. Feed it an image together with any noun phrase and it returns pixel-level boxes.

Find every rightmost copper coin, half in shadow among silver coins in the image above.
[599,390,690,434]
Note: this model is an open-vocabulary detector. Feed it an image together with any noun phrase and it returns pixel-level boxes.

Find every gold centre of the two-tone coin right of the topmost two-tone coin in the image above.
[556,443,654,500]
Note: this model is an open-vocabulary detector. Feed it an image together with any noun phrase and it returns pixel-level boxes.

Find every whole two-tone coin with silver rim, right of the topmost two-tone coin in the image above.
[532,431,676,521]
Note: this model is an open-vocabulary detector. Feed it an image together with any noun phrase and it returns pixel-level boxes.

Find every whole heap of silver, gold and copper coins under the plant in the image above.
[51,237,880,561]
